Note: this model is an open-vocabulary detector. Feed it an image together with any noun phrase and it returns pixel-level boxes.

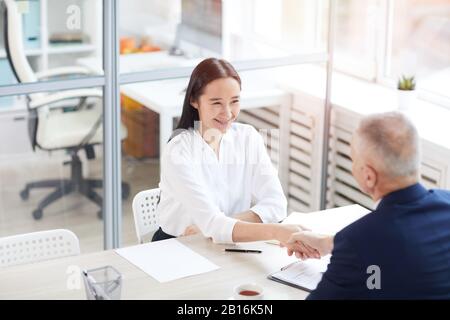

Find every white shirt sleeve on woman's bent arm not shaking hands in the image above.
[250,129,287,223]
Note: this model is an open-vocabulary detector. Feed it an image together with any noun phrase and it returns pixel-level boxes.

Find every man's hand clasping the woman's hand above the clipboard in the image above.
[286,231,334,259]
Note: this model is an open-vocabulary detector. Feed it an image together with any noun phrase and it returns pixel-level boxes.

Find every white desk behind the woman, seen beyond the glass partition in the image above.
[78,52,290,155]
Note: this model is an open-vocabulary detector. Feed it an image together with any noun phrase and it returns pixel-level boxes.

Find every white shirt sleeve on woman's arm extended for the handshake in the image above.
[161,139,237,243]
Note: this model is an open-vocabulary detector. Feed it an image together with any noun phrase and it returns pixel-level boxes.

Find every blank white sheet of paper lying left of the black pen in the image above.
[115,239,220,282]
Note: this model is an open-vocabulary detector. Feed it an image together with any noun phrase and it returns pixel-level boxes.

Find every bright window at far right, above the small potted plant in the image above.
[386,0,450,102]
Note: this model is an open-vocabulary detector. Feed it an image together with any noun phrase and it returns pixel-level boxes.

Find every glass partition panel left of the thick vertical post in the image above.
[0,0,104,252]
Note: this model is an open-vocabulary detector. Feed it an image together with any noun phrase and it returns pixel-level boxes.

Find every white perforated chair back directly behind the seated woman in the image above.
[133,188,160,243]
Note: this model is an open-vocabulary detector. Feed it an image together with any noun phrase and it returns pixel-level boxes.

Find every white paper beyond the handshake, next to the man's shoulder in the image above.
[283,204,370,235]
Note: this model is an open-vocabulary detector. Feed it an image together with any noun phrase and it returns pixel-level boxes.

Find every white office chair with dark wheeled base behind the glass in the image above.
[3,0,129,220]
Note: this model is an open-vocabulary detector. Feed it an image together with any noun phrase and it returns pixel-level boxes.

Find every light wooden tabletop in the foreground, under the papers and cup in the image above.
[0,235,308,299]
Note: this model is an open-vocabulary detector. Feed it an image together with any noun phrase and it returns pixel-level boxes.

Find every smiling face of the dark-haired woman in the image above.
[191,78,241,133]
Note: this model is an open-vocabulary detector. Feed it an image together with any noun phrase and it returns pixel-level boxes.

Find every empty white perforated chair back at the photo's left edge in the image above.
[0,229,80,267]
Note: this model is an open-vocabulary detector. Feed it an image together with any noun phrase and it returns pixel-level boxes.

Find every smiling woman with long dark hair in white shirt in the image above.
[153,58,312,248]
